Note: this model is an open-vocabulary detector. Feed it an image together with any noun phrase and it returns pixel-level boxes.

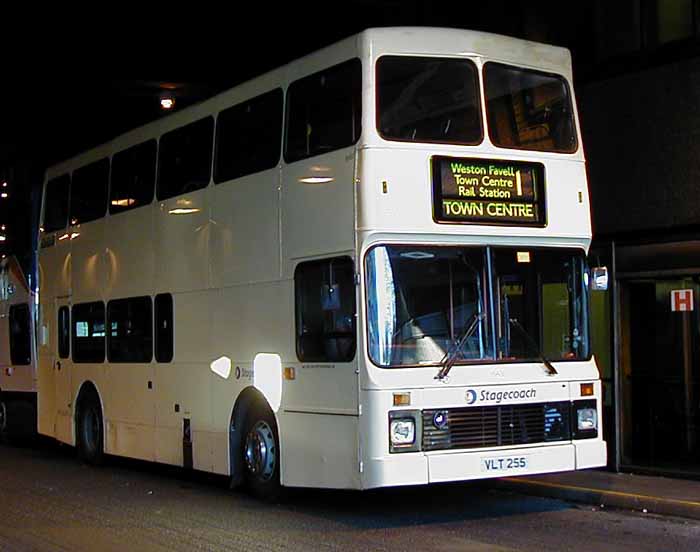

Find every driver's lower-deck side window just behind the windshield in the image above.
[294,257,356,362]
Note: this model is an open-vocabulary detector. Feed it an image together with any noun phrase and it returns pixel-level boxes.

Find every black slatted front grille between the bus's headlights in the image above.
[423,401,571,451]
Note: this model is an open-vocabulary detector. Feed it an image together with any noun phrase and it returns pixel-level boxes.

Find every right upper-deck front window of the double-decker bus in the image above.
[484,63,577,153]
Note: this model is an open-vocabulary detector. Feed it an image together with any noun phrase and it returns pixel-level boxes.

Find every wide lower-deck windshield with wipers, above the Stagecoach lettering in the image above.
[365,246,589,368]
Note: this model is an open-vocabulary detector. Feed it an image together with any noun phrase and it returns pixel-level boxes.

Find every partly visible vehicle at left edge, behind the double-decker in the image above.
[0,256,37,440]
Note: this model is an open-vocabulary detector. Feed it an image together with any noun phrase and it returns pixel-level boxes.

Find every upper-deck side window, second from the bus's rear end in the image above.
[70,159,109,224]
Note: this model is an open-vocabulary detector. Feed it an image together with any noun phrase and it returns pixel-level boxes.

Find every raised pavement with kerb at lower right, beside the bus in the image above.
[497,470,700,520]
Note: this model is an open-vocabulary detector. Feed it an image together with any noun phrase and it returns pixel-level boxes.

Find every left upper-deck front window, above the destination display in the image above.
[377,56,483,145]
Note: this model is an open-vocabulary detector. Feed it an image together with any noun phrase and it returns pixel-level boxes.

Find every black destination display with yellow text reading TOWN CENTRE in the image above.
[433,157,546,226]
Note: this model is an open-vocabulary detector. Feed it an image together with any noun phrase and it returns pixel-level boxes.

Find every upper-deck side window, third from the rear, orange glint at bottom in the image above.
[109,140,157,214]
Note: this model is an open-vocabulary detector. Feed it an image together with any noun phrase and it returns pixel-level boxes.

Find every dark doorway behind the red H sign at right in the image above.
[620,276,700,476]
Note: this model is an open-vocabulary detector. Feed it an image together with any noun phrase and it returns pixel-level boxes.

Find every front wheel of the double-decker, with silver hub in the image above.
[243,404,282,502]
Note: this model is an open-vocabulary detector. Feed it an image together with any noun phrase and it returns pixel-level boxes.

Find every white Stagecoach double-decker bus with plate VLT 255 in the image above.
[38,28,606,495]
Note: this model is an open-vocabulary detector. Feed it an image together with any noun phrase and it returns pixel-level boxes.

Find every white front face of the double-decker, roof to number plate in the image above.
[357,31,607,488]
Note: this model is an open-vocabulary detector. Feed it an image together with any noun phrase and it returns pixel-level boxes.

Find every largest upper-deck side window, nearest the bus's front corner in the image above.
[284,59,362,162]
